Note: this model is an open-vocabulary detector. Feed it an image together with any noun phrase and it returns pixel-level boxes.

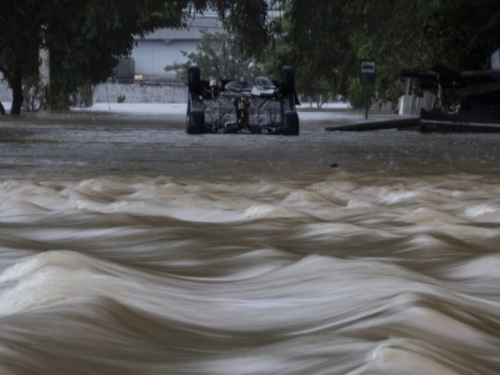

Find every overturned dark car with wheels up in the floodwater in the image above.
[186,66,300,135]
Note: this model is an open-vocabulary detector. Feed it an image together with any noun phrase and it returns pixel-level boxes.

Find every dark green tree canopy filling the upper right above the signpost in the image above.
[268,0,500,107]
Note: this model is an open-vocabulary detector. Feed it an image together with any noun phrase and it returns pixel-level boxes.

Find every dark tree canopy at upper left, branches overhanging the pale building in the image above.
[0,0,269,115]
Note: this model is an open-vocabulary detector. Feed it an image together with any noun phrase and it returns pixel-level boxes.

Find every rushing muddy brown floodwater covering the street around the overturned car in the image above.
[0,107,500,375]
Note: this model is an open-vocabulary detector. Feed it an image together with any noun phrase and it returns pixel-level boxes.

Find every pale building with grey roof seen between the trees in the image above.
[117,12,223,79]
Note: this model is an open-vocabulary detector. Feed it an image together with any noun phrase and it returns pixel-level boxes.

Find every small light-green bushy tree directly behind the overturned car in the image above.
[165,32,261,80]
